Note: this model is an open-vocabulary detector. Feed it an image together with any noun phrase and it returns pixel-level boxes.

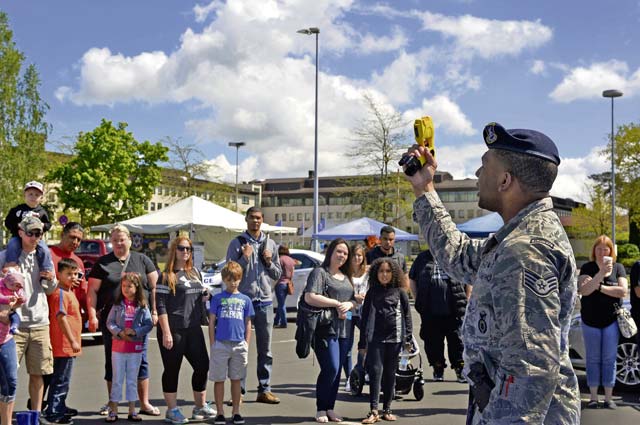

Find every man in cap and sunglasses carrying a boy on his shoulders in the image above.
[0,216,57,411]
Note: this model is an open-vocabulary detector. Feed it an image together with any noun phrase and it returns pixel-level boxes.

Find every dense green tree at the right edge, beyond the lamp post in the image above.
[608,123,640,245]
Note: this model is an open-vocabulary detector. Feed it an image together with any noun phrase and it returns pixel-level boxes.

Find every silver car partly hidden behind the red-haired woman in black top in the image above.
[569,300,640,391]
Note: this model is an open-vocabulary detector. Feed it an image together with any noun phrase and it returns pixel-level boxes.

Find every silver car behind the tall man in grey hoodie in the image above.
[202,249,324,311]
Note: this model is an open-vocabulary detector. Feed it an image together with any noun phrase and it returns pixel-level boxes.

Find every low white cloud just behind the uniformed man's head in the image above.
[551,146,609,202]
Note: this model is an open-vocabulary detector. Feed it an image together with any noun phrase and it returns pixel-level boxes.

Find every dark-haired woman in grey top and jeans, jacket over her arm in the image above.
[304,238,356,423]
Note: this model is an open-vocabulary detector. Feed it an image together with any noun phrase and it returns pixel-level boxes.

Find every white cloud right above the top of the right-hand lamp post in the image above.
[549,60,640,103]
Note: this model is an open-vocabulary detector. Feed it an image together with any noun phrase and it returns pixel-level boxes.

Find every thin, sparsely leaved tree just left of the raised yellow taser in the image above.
[346,94,410,223]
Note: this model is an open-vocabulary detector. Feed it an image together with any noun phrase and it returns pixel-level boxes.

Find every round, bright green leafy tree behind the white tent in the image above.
[48,119,168,226]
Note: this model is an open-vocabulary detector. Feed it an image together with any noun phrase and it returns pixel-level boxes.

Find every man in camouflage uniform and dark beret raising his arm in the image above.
[407,123,580,424]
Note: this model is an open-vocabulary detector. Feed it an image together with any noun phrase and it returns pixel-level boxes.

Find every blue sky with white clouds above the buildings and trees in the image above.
[5,0,640,200]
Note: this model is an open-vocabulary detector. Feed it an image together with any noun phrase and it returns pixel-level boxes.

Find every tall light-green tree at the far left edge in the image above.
[0,12,51,220]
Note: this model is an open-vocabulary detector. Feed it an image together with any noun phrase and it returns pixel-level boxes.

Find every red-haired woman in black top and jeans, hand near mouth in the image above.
[578,235,627,409]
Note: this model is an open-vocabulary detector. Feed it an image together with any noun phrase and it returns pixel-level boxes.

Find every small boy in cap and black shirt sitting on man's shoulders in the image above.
[4,181,53,271]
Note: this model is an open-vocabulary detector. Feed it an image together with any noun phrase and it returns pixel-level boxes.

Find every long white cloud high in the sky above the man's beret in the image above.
[414,12,553,59]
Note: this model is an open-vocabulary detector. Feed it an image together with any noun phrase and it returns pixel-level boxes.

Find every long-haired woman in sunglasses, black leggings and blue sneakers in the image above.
[156,236,215,424]
